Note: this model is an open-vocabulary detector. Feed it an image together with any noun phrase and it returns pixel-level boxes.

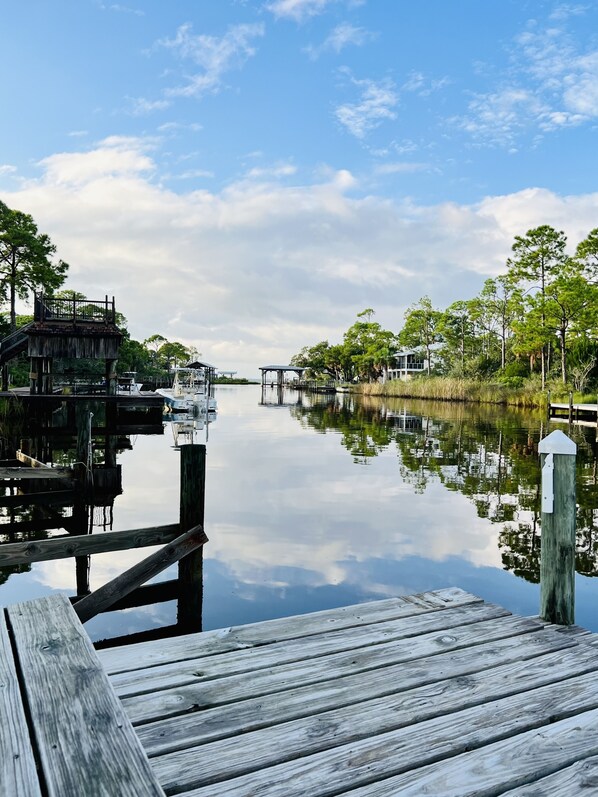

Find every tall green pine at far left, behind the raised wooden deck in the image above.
[0,202,68,332]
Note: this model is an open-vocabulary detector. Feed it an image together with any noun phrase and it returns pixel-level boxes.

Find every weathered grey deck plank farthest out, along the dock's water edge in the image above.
[98,587,482,674]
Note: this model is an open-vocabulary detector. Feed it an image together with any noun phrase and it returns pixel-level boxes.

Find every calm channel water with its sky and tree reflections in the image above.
[0,386,598,639]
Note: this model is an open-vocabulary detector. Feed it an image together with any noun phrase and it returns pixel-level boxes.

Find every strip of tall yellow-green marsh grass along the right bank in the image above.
[356,376,596,409]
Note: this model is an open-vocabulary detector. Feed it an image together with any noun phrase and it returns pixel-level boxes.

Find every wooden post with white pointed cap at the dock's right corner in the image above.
[538,429,577,625]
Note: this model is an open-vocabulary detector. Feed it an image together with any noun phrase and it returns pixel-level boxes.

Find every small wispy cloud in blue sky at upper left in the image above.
[156,23,264,97]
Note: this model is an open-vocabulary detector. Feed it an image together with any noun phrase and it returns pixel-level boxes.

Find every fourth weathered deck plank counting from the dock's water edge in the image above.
[137,634,596,764]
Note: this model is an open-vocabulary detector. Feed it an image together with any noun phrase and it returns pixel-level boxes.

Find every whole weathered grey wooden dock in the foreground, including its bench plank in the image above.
[5,588,598,797]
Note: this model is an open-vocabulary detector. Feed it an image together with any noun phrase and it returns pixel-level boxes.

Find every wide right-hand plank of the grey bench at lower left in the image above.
[6,595,163,797]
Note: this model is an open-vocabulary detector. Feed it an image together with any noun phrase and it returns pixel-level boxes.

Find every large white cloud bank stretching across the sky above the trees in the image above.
[2,137,598,376]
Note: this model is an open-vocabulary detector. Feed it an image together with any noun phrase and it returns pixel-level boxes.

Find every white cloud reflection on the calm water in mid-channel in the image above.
[28,387,502,595]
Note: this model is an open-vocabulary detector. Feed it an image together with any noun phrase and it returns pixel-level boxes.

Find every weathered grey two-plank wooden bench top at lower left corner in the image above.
[0,595,164,797]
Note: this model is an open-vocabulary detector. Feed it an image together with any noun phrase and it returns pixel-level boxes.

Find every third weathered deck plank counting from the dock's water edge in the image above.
[124,617,552,723]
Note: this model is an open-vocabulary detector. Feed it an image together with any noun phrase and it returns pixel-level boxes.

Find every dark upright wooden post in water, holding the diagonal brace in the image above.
[177,444,206,633]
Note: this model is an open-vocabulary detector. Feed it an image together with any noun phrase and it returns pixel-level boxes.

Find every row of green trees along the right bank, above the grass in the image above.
[291,224,598,391]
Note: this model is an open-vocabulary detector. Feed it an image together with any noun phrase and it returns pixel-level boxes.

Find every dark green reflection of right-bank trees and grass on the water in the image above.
[292,397,598,583]
